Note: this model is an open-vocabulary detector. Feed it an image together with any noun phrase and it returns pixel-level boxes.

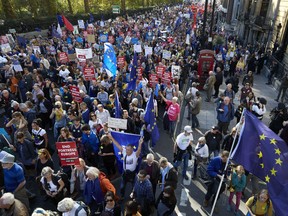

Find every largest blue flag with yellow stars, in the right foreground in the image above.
[232,111,288,216]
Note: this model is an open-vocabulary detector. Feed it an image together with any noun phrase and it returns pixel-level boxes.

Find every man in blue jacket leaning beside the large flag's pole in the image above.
[203,151,229,213]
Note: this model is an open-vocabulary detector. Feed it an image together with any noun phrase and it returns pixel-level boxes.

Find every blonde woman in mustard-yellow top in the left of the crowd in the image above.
[50,101,66,140]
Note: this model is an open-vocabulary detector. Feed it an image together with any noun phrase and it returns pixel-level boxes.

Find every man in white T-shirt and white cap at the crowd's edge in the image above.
[174,125,193,180]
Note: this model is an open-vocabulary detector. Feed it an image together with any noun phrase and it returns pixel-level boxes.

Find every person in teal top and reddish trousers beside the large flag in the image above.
[227,165,246,216]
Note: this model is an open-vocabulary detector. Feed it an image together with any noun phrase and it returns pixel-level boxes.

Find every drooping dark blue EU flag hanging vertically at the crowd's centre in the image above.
[144,92,160,146]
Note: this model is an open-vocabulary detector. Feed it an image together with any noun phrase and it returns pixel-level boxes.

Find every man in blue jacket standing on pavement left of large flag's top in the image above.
[216,97,235,135]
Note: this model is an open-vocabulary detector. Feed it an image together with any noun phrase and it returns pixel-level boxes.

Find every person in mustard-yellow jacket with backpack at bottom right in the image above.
[246,189,273,216]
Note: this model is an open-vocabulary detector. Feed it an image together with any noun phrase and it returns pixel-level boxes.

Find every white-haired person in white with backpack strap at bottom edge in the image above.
[57,198,90,216]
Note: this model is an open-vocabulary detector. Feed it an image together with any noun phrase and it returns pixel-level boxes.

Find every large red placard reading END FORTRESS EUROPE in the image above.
[56,142,80,166]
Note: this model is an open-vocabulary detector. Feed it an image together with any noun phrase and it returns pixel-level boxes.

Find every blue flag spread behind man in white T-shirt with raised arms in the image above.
[111,131,140,173]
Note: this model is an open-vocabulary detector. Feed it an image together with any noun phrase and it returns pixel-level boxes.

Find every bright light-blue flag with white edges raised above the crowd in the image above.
[103,43,117,77]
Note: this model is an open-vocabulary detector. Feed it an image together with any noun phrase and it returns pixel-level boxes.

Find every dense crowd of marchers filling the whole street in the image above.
[0,1,288,216]
